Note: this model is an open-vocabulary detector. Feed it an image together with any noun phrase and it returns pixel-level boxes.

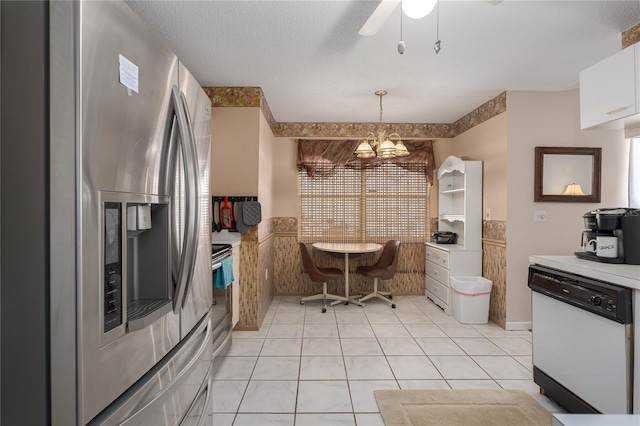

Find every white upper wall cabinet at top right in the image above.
[580,43,640,133]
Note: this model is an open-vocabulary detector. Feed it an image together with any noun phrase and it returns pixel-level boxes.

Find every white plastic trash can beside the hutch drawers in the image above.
[451,276,493,324]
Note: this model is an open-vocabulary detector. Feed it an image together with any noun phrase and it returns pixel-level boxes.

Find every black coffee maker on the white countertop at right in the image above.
[575,208,640,265]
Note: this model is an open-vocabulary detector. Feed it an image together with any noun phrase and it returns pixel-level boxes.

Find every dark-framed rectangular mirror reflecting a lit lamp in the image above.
[533,146,602,203]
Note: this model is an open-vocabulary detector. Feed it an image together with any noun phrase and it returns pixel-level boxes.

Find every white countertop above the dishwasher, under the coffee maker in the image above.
[529,255,640,290]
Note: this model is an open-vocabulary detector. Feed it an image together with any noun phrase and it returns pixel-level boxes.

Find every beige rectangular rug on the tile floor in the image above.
[373,389,552,426]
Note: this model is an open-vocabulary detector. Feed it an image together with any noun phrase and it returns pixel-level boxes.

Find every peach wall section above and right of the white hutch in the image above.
[431,111,509,220]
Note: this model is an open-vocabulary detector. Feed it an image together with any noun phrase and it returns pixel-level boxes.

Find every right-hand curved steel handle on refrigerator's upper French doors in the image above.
[180,91,201,308]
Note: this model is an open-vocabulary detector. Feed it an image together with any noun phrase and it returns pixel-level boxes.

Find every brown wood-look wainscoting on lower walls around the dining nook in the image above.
[236,217,507,330]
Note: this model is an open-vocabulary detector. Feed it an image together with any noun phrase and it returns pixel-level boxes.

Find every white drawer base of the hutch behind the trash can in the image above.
[425,243,482,315]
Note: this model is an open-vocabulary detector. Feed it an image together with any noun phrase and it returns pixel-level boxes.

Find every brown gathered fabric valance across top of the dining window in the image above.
[297,139,436,185]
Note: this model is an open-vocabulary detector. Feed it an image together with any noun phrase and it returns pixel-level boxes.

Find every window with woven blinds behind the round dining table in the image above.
[298,163,429,243]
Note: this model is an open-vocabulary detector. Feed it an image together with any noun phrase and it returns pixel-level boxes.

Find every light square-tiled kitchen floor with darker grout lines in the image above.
[211,296,563,426]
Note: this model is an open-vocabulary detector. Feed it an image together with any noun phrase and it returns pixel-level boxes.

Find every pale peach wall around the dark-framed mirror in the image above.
[506,90,629,328]
